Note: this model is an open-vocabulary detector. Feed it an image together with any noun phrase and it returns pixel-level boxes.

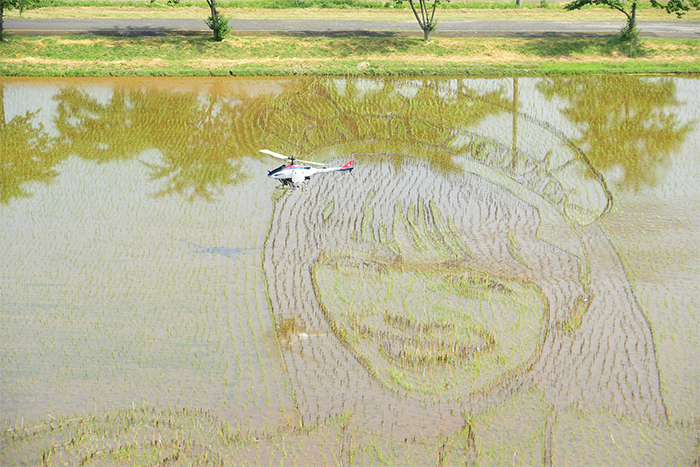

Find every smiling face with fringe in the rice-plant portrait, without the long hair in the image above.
[314,163,556,400]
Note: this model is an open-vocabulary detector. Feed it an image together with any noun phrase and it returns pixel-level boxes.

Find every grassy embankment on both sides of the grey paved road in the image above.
[0,0,700,76]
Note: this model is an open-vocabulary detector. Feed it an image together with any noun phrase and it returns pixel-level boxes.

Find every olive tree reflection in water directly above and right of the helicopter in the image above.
[257,78,508,175]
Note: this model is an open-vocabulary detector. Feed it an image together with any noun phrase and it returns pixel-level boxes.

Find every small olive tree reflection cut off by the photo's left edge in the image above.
[0,83,58,204]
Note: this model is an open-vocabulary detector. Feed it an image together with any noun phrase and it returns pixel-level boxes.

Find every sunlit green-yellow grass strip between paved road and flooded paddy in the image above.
[0,36,700,76]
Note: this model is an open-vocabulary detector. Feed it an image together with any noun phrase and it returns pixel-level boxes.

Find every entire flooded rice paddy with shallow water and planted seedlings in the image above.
[0,76,700,465]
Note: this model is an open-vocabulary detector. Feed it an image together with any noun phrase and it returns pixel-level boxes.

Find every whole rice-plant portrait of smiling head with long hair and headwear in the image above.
[264,77,665,442]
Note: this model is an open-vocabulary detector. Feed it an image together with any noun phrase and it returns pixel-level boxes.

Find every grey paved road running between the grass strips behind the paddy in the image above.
[4,18,700,39]
